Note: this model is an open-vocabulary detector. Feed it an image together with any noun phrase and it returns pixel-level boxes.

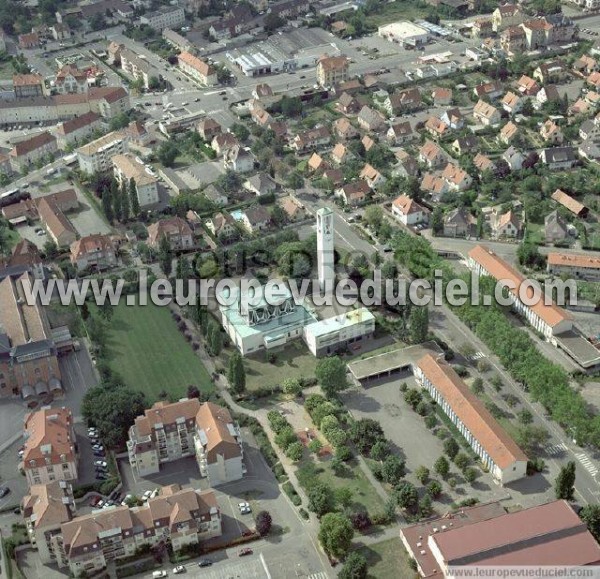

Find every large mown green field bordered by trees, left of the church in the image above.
[107,303,214,400]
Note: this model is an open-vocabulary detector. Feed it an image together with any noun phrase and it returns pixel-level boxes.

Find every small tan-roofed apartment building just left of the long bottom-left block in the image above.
[21,480,76,565]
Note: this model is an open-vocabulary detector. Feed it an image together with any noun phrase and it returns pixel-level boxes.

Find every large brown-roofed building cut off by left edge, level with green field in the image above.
[0,271,62,400]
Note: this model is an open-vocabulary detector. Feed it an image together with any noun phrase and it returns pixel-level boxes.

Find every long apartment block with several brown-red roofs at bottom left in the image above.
[52,485,222,577]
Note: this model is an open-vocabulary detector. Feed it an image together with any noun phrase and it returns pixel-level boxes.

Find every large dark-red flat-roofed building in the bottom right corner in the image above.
[400,500,600,579]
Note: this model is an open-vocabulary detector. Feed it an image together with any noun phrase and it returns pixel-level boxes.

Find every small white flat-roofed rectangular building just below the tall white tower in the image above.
[303,308,375,357]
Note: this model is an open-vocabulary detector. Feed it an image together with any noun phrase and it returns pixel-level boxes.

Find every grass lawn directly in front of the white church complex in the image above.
[221,340,317,392]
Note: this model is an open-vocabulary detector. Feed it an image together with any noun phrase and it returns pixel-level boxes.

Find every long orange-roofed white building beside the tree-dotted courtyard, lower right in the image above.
[413,354,527,484]
